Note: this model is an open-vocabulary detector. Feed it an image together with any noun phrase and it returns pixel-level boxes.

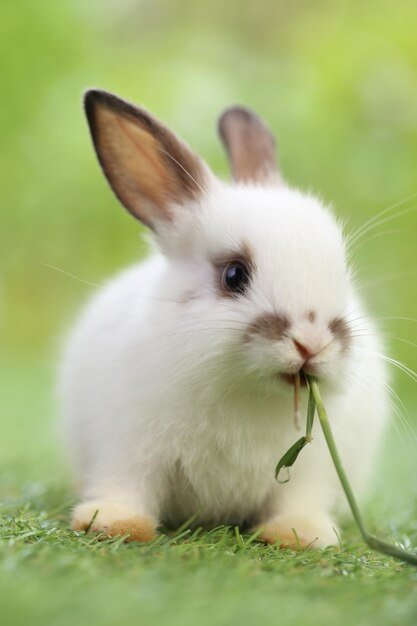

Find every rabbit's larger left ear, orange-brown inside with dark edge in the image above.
[84,89,209,230]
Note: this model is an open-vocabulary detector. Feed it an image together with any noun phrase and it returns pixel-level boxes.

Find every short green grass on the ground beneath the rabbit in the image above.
[0,497,417,626]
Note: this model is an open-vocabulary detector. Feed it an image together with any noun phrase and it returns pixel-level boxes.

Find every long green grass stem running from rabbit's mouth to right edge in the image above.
[307,376,417,565]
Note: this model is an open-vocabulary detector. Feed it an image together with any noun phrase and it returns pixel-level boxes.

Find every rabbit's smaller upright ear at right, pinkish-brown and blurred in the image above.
[218,107,282,184]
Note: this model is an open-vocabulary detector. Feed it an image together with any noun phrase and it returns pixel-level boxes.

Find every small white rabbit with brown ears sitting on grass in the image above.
[58,89,388,548]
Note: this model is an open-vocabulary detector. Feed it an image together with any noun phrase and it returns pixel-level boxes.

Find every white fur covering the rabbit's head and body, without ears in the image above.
[60,180,387,545]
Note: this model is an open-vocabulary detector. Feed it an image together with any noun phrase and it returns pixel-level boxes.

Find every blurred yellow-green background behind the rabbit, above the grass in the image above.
[0,0,417,523]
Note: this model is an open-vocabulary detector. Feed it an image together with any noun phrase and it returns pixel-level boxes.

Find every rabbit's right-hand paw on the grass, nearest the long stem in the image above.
[258,513,338,550]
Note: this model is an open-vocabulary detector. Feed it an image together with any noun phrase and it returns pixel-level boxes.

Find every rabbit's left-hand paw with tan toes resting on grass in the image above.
[71,500,157,542]
